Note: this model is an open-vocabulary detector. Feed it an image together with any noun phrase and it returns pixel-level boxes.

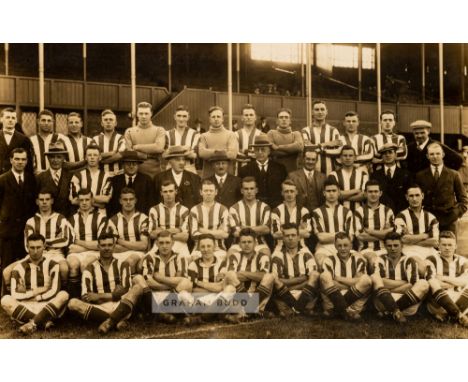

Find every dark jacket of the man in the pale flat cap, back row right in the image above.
[405,138,463,176]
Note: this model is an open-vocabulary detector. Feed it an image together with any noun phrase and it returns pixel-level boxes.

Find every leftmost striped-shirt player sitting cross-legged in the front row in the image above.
[1,233,68,335]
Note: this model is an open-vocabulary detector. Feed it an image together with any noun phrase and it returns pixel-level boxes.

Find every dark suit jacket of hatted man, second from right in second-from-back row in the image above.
[371,166,414,215]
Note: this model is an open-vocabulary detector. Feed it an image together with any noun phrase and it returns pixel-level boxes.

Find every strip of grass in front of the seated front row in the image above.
[0,311,468,339]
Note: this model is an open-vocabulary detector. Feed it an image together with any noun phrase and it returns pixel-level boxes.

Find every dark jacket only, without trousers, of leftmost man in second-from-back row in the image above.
[0,170,36,238]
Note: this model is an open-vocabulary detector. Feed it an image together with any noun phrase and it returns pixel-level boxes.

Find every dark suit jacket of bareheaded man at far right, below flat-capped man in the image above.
[416,165,468,232]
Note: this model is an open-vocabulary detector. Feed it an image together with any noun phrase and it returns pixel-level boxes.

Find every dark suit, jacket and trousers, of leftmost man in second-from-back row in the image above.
[0,170,36,269]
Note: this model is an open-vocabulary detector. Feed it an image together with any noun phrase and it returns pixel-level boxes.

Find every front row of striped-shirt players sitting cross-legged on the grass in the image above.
[1,224,468,334]
